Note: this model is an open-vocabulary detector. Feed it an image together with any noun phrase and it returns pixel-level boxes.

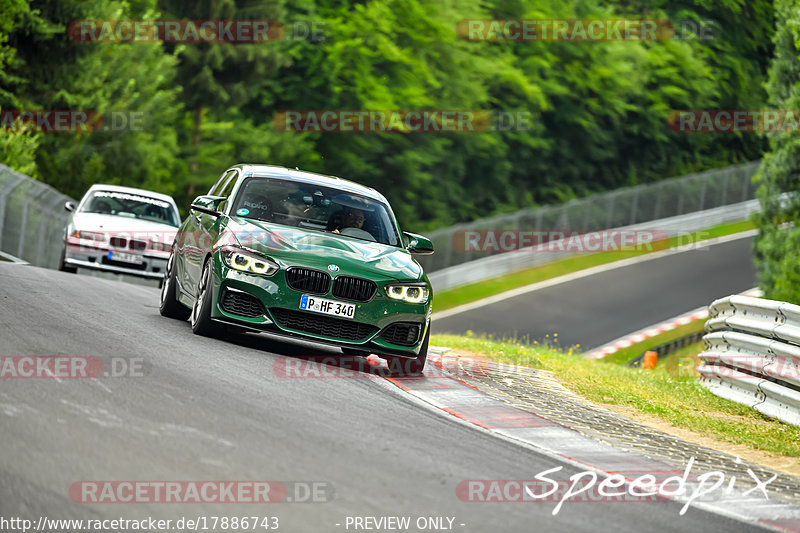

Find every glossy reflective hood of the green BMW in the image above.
[227,218,422,280]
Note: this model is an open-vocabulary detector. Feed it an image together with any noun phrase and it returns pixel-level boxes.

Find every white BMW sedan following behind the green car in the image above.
[59,185,180,279]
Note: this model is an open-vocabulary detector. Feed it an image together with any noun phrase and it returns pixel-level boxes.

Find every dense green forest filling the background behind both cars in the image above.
[0,0,773,231]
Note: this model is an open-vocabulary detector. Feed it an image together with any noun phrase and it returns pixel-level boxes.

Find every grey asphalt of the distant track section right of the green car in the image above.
[434,237,756,350]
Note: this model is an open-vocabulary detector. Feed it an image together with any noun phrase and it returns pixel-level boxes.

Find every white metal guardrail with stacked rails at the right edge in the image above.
[697,296,800,426]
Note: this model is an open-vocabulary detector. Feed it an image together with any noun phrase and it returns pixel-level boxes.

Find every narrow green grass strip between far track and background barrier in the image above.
[434,221,755,311]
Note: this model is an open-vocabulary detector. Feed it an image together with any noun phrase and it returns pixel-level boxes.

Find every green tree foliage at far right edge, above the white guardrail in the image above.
[754,0,800,303]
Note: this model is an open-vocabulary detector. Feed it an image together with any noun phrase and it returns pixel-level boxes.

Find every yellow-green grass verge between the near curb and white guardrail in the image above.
[431,335,800,457]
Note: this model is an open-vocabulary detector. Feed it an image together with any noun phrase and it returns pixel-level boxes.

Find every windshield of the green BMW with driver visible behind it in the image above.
[231,178,400,246]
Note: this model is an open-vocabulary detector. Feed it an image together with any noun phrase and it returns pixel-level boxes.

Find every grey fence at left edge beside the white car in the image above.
[0,165,74,268]
